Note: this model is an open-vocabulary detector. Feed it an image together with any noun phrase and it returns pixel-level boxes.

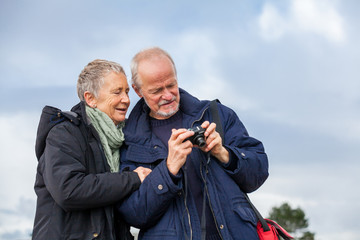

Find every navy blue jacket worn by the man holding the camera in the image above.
[118,89,268,240]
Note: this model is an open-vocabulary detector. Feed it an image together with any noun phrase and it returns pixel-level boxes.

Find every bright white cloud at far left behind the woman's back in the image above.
[0,113,39,209]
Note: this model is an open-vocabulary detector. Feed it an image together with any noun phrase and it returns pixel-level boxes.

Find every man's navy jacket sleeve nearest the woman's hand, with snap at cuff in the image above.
[117,160,182,229]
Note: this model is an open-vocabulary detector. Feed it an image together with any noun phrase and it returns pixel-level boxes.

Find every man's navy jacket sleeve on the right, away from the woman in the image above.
[218,105,269,193]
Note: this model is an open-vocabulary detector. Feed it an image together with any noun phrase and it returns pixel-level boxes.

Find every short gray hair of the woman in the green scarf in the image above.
[77,59,126,101]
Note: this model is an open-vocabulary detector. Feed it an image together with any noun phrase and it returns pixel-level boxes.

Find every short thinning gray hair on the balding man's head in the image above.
[130,47,177,89]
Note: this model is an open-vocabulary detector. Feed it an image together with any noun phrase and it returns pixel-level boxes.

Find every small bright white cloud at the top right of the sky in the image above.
[258,0,346,43]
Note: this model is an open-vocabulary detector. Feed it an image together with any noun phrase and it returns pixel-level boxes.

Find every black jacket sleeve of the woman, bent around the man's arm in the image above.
[40,122,141,211]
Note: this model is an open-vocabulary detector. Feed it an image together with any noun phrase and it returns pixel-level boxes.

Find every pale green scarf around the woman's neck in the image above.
[86,106,125,172]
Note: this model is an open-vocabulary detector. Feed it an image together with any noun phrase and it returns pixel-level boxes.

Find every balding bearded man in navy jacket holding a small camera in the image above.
[118,48,268,240]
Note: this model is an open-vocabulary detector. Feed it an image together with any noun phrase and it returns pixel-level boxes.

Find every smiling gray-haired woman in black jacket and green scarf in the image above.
[32,60,151,240]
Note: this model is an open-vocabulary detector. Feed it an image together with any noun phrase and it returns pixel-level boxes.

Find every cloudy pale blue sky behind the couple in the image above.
[0,0,360,240]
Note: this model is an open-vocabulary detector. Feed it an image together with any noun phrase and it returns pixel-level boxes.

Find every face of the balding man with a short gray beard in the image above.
[133,57,180,119]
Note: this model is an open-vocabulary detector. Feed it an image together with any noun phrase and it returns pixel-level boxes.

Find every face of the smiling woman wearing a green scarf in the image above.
[95,72,130,125]
